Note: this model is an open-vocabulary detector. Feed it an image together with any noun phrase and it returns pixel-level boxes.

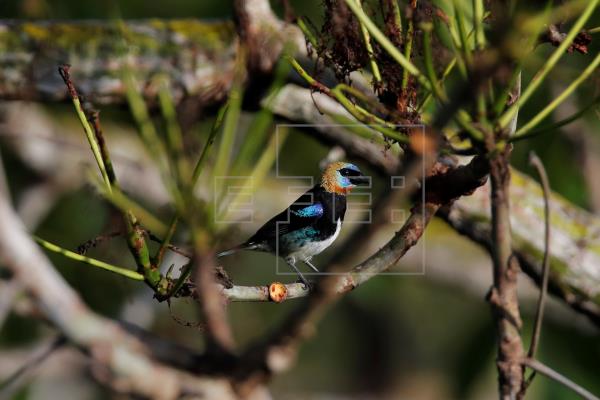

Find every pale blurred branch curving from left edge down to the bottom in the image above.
[0,175,240,399]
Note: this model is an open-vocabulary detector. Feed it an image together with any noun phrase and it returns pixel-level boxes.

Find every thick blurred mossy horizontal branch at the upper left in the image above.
[0,20,237,104]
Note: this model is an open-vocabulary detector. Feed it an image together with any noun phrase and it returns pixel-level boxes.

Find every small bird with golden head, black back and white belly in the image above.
[217,162,368,287]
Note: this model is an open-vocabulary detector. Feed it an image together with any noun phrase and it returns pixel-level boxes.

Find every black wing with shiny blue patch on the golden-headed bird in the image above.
[246,186,324,244]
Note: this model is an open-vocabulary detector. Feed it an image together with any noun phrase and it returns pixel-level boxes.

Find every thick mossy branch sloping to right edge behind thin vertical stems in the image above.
[442,169,600,325]
